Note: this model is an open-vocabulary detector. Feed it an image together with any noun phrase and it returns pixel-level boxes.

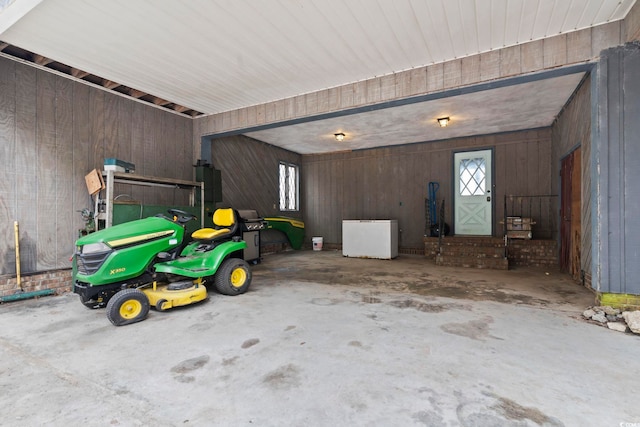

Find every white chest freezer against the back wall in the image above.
[342,219,398,259]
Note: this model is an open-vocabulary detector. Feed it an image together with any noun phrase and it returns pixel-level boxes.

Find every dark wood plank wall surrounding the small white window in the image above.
[210,135,303,219]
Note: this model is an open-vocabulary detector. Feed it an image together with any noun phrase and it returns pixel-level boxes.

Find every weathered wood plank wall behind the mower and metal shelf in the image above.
[0,57,193,275]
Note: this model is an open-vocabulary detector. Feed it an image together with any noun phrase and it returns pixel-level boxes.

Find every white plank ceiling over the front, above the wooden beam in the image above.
[0,0,635,113]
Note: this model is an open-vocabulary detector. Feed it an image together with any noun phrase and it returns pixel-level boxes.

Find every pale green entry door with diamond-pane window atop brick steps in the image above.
[453,150,493,236]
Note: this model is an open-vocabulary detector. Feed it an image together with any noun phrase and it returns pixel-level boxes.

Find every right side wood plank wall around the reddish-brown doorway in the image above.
[551,77,593,279]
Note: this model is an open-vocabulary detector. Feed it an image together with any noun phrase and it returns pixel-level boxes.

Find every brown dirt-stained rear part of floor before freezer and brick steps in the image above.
[254,250,595,312]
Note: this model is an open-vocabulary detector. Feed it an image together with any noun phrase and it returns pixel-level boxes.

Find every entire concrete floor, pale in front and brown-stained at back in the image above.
[0,251,640,426]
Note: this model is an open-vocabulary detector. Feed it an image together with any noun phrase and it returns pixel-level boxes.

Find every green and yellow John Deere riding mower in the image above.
[73,209,251,326]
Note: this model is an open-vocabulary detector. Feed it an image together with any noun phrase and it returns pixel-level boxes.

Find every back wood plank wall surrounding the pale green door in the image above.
[301,128,552,248]
